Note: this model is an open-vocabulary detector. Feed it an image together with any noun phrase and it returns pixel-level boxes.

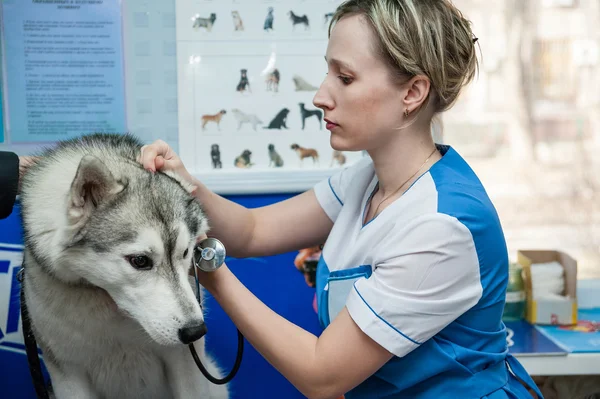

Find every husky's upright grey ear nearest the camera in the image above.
[67,155,127,231]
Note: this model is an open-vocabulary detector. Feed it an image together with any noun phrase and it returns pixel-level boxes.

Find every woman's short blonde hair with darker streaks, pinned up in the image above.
[329,0,478,112]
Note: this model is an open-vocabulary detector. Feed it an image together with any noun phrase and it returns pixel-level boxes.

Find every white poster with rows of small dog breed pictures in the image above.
[176,0,362,173]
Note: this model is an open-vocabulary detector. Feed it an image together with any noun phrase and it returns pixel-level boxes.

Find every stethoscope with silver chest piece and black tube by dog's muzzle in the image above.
[189,238,244,384]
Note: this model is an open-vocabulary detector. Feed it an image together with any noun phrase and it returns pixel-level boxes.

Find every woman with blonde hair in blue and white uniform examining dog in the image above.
[141,0,541,399]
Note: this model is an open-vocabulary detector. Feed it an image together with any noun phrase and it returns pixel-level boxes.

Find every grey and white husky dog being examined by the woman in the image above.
[21,134,229,399]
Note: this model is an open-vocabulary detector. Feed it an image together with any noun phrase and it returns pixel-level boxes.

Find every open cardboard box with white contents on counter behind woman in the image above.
[517,250,577,325]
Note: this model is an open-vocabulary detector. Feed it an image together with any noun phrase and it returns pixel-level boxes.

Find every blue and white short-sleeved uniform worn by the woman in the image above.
[315,145,542,399]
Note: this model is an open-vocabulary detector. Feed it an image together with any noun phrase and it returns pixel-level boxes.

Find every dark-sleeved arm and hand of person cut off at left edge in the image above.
[0,151,33,219]
